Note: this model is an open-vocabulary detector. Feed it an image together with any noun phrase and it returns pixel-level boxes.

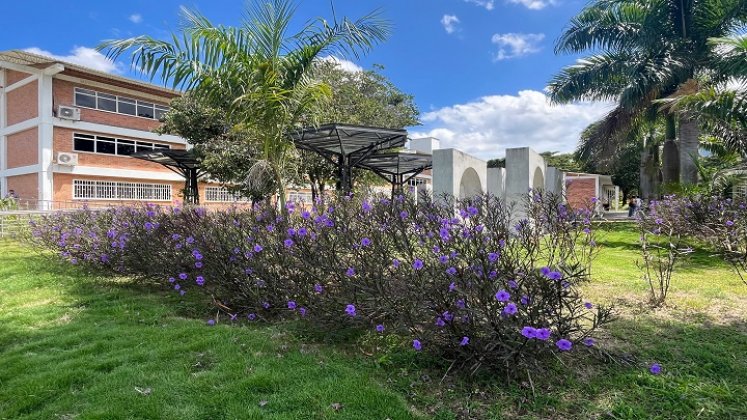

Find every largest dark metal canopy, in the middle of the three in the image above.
[290,124,407,191]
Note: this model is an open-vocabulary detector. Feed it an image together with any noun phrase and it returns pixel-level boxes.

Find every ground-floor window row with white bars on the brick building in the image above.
[73,179,171,201]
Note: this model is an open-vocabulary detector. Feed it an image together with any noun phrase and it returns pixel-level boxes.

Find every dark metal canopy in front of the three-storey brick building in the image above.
[131,149,206,204]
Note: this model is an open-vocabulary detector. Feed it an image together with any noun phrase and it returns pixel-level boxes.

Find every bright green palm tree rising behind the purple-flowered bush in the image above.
[99,0,391,204]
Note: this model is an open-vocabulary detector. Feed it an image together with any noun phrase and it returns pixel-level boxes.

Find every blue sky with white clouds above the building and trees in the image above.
[0,0,610,159]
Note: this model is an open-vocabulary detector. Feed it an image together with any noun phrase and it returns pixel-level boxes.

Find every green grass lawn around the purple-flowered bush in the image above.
[0,227,747,419]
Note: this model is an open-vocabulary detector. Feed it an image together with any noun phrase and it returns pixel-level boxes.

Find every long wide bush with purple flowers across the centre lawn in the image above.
[33,192,609,371]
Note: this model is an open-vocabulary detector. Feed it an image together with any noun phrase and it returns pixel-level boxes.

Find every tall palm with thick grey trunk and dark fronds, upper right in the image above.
[549,0,747,184]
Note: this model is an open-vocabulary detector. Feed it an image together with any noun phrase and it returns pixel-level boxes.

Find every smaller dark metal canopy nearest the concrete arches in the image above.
[359,152,433,192]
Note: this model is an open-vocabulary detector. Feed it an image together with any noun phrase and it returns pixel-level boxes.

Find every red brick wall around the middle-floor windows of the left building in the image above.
[53,127,185,172]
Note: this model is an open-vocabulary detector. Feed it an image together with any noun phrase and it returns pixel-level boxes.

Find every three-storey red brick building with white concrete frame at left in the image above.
[0,51,233,209]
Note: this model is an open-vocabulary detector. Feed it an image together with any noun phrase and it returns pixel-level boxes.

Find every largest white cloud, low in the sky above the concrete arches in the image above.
[411,90,613,159]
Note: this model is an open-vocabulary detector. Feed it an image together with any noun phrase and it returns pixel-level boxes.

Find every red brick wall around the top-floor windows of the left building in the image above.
[52,79,169,131]
